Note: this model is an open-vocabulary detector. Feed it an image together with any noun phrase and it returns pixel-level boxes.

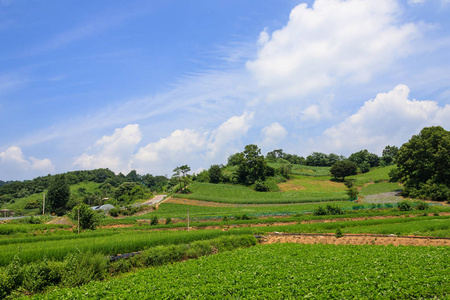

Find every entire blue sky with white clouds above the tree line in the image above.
[0,0,450,181]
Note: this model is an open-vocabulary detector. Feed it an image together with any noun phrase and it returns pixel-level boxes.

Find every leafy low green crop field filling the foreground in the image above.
[29,244,450,299]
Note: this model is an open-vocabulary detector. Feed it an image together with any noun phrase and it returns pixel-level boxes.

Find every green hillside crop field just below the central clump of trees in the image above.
[174,182,348,204]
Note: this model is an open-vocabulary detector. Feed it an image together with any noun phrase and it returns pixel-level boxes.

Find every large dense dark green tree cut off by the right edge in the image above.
[395,126,450,200]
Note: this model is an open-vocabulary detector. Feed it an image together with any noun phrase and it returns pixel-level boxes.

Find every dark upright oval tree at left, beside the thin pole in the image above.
[46,174,70,216]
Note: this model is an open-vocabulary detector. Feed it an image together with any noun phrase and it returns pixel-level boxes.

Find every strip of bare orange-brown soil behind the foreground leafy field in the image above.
[261,234,450,246]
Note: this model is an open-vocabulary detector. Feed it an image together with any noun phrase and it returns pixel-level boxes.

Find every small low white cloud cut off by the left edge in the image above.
[0,146,55,180]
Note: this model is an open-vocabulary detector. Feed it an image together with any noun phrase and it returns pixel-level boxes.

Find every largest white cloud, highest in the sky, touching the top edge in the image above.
[246,0,420,100]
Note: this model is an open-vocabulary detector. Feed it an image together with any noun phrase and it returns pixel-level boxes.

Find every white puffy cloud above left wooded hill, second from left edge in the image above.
[74,124,142,173]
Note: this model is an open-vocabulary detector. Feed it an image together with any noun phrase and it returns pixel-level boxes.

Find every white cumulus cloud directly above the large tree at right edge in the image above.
[324,85,450,153]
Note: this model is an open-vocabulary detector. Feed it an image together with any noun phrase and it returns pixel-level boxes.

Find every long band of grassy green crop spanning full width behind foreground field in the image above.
[0,216,450,266]
